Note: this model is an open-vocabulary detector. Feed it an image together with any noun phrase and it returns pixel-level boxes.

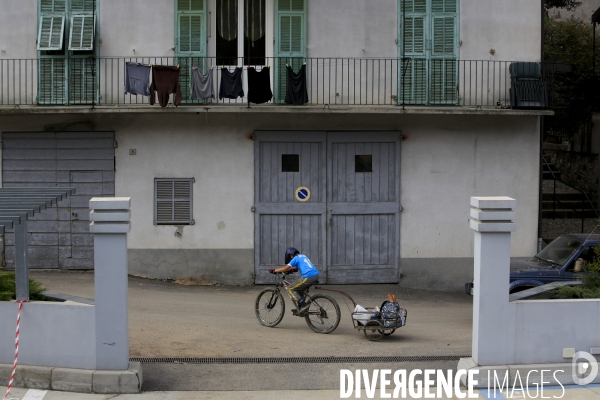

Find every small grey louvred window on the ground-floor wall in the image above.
[154,178,195,225]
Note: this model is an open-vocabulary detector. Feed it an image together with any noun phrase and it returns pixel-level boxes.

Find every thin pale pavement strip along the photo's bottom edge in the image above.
[0,385,600,400]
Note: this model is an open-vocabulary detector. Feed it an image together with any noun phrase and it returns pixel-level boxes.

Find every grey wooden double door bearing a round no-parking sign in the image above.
[255,131,400,284]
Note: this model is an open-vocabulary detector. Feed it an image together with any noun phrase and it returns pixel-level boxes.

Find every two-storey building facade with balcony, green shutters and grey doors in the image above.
[0,0,545,291]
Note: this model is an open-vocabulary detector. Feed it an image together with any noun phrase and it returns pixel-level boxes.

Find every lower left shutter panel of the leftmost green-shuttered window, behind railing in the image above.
[38,58,66,104]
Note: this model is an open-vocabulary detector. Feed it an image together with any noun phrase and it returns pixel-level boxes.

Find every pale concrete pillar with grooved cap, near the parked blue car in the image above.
[470,197,516,365]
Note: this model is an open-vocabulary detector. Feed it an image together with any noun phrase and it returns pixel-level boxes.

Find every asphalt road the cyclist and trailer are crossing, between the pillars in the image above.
[31,271,472,390]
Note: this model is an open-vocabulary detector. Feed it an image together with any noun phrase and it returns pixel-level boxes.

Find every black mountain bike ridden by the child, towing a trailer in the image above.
[254,268,341,333]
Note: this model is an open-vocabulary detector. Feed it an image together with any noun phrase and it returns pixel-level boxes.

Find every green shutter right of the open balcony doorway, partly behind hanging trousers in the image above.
[275,0,306,103]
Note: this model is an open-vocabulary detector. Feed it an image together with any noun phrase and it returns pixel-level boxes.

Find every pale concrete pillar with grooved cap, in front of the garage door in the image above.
[90,197,131,371]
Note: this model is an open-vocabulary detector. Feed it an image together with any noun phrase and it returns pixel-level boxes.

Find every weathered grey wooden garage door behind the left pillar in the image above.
[2,132,115,269]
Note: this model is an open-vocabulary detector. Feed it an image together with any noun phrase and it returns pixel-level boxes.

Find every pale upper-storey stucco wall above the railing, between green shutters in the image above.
[0,0,541,61]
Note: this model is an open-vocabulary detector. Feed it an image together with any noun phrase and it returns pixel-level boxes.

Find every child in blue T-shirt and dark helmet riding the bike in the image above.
[269,247,319,314]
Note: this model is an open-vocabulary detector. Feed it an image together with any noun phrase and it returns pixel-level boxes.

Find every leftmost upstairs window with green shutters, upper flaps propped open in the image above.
[37,0,99,104]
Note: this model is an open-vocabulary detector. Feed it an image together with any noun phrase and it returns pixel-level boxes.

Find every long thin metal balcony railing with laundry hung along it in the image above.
[0,57,548,107]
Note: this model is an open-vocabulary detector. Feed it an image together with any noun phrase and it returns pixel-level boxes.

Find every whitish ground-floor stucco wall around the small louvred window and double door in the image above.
[0,112,539,258]
